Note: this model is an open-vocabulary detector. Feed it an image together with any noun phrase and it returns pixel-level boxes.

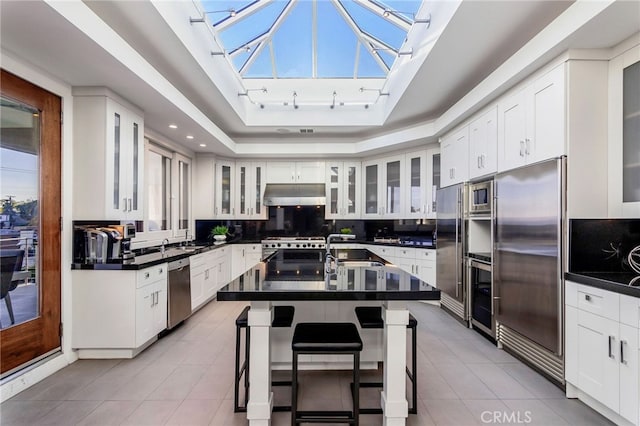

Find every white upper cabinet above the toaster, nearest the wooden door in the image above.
[73,88,144,220]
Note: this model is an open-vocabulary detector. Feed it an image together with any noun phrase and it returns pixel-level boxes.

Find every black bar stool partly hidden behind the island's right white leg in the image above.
[355,306,418,414]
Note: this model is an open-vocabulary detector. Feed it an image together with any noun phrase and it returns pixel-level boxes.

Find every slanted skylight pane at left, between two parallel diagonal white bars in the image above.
[219,1,287,52]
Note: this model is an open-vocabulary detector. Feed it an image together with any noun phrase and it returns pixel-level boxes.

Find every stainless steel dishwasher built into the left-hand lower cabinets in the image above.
[167,257,191,330]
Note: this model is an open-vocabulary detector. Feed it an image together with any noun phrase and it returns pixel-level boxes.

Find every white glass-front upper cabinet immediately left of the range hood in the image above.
[234,161,267,219]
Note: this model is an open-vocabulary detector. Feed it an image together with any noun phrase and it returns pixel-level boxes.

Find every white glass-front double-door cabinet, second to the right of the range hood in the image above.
[362,155,405,219]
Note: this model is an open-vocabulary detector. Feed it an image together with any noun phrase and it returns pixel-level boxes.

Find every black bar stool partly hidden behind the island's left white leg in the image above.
[233,306,295,413]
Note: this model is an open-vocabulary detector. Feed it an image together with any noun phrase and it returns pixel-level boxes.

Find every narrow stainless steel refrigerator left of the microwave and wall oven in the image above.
[436,184,467,321]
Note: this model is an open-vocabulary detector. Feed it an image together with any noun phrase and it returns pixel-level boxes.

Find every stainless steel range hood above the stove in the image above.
[264,183,327,206]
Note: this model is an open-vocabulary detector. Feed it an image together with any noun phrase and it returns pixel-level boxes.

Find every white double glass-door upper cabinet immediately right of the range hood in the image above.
[325,161,362,219]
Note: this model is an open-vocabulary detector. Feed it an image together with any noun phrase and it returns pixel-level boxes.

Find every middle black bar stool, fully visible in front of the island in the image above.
[291,322,362,426]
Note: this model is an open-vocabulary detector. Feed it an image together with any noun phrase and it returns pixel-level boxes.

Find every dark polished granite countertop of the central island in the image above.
[218,250,440,301]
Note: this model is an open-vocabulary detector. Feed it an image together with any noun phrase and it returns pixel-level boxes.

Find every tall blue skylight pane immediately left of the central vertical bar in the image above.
[273,1,313,78]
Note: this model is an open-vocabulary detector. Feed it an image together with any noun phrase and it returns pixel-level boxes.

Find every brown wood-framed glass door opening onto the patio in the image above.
[0,70,61,376]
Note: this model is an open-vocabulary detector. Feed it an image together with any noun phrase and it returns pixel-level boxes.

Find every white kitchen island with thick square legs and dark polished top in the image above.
[217,250,440,426]
